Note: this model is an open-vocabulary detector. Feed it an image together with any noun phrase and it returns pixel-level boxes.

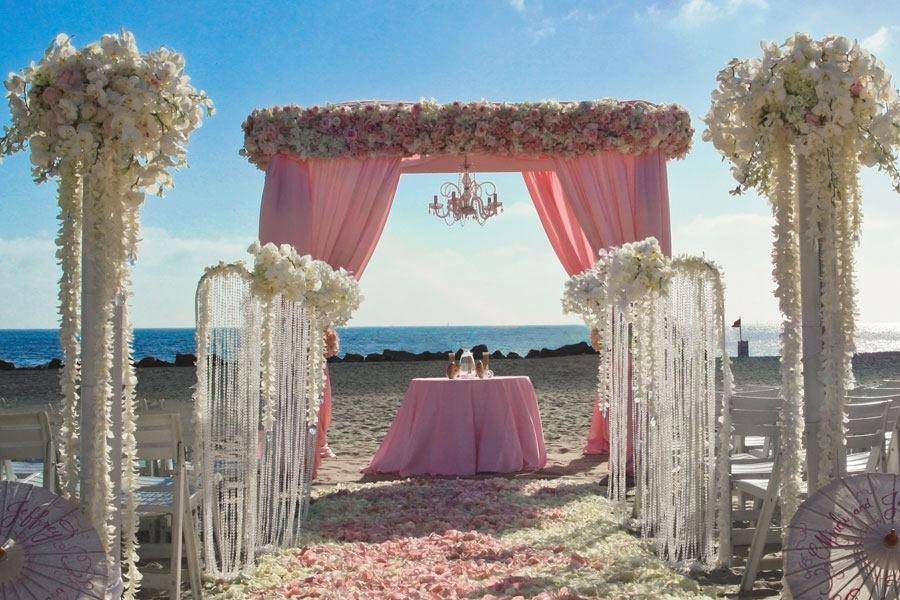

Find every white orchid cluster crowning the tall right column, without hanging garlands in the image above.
[703,33,900,192]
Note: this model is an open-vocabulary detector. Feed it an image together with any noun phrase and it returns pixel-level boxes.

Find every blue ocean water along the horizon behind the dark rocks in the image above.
[0,323,900,366]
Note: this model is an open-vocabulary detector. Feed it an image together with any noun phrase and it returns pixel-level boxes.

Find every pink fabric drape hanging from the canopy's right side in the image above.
[523,152,672,454]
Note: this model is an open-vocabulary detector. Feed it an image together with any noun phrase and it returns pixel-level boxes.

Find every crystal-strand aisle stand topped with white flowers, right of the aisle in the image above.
[563,238,732,564]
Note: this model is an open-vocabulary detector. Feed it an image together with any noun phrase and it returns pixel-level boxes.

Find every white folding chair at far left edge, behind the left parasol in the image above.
[0,412,57,493]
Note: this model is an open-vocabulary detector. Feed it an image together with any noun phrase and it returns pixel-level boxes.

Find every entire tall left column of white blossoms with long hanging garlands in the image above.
[0,31,213,598]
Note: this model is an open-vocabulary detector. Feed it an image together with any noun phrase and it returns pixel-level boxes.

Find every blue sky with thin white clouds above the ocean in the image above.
[0,0,900,328]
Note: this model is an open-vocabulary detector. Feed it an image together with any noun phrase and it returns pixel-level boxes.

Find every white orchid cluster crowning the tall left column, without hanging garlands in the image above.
[0,31,214,194]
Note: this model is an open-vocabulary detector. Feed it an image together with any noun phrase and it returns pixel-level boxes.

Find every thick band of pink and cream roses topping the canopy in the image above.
[241,99,694,169]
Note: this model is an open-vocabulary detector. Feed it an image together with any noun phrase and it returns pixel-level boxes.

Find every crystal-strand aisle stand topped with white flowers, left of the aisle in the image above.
[194,248,362,578]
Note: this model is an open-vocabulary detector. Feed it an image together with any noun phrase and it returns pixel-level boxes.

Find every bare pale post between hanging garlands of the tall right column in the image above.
[797,157,825,493]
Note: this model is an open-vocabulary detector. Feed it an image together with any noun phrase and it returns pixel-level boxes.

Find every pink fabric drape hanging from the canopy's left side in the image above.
[259,155,400,476]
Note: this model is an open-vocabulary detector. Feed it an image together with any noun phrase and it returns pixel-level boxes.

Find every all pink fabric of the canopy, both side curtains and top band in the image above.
[259,150,671,464]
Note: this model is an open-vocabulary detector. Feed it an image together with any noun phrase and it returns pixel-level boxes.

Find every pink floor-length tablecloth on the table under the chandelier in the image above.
[363,377,547,476]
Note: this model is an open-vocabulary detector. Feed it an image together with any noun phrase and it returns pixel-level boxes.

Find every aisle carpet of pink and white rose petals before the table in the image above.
[210,478,711,600]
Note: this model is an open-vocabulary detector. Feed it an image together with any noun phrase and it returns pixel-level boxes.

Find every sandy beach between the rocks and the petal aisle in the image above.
[0,353,900,485]
